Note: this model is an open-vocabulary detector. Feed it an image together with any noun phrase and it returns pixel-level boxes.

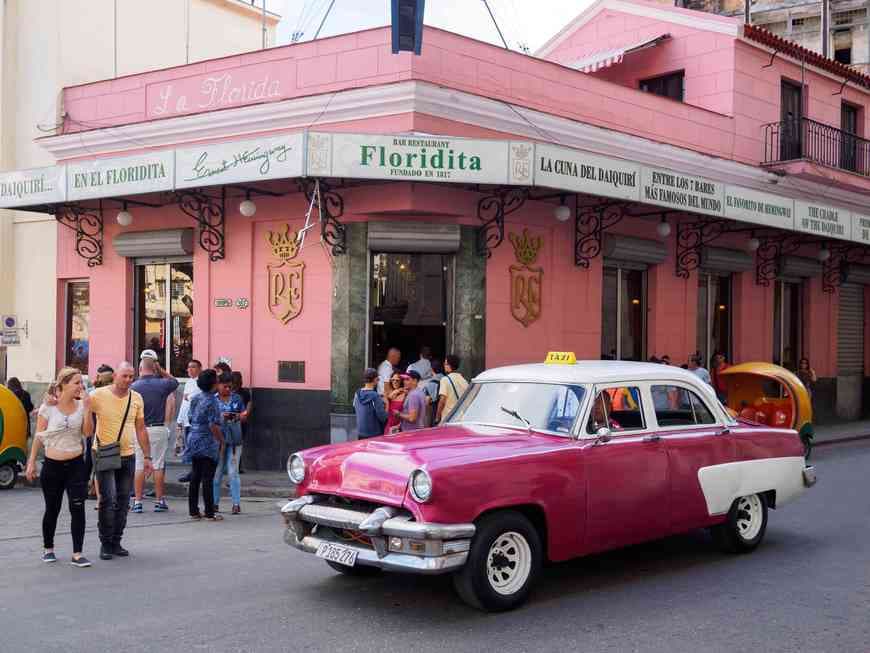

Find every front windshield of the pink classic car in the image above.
[447,381,586,434]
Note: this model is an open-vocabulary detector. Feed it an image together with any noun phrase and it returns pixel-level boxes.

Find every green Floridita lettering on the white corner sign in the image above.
[360,138,481,179]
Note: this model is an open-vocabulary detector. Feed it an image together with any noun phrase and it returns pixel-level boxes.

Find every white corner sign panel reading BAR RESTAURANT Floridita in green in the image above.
[308,133,534,184]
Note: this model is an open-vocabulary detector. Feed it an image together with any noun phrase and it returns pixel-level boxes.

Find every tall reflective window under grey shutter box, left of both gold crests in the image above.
[133,261,193,377]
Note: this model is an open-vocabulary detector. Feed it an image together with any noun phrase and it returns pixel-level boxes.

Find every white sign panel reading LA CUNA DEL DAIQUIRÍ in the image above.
[535,143,640,201]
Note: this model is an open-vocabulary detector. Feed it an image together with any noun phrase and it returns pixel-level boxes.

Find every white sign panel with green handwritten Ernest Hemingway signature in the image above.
[175,132,305,188]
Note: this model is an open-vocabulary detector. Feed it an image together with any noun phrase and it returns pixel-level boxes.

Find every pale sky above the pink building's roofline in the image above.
[268,0,592,52]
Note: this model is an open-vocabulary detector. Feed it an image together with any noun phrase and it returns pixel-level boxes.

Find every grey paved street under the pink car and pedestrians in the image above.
[0,441,870,653]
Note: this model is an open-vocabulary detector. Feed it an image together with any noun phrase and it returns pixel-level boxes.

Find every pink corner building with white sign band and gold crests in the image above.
[0,0,870,468]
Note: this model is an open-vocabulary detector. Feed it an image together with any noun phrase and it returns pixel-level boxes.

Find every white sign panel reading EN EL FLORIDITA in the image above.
[67,150,175,200]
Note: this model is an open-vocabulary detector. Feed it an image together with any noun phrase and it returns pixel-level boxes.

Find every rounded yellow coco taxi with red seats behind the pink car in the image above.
[721,362,814,458]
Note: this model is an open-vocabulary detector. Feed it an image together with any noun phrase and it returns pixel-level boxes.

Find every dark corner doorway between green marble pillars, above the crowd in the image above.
[369,252,454,367]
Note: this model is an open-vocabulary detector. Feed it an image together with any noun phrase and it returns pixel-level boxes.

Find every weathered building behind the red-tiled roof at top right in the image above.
[676,0,870,72]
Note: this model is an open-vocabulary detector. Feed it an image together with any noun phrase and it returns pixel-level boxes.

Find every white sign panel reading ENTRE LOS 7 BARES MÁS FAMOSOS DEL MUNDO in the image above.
[640,167,724,215]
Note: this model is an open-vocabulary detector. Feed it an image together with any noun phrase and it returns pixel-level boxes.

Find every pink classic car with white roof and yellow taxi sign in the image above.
[282,354,816,611]
